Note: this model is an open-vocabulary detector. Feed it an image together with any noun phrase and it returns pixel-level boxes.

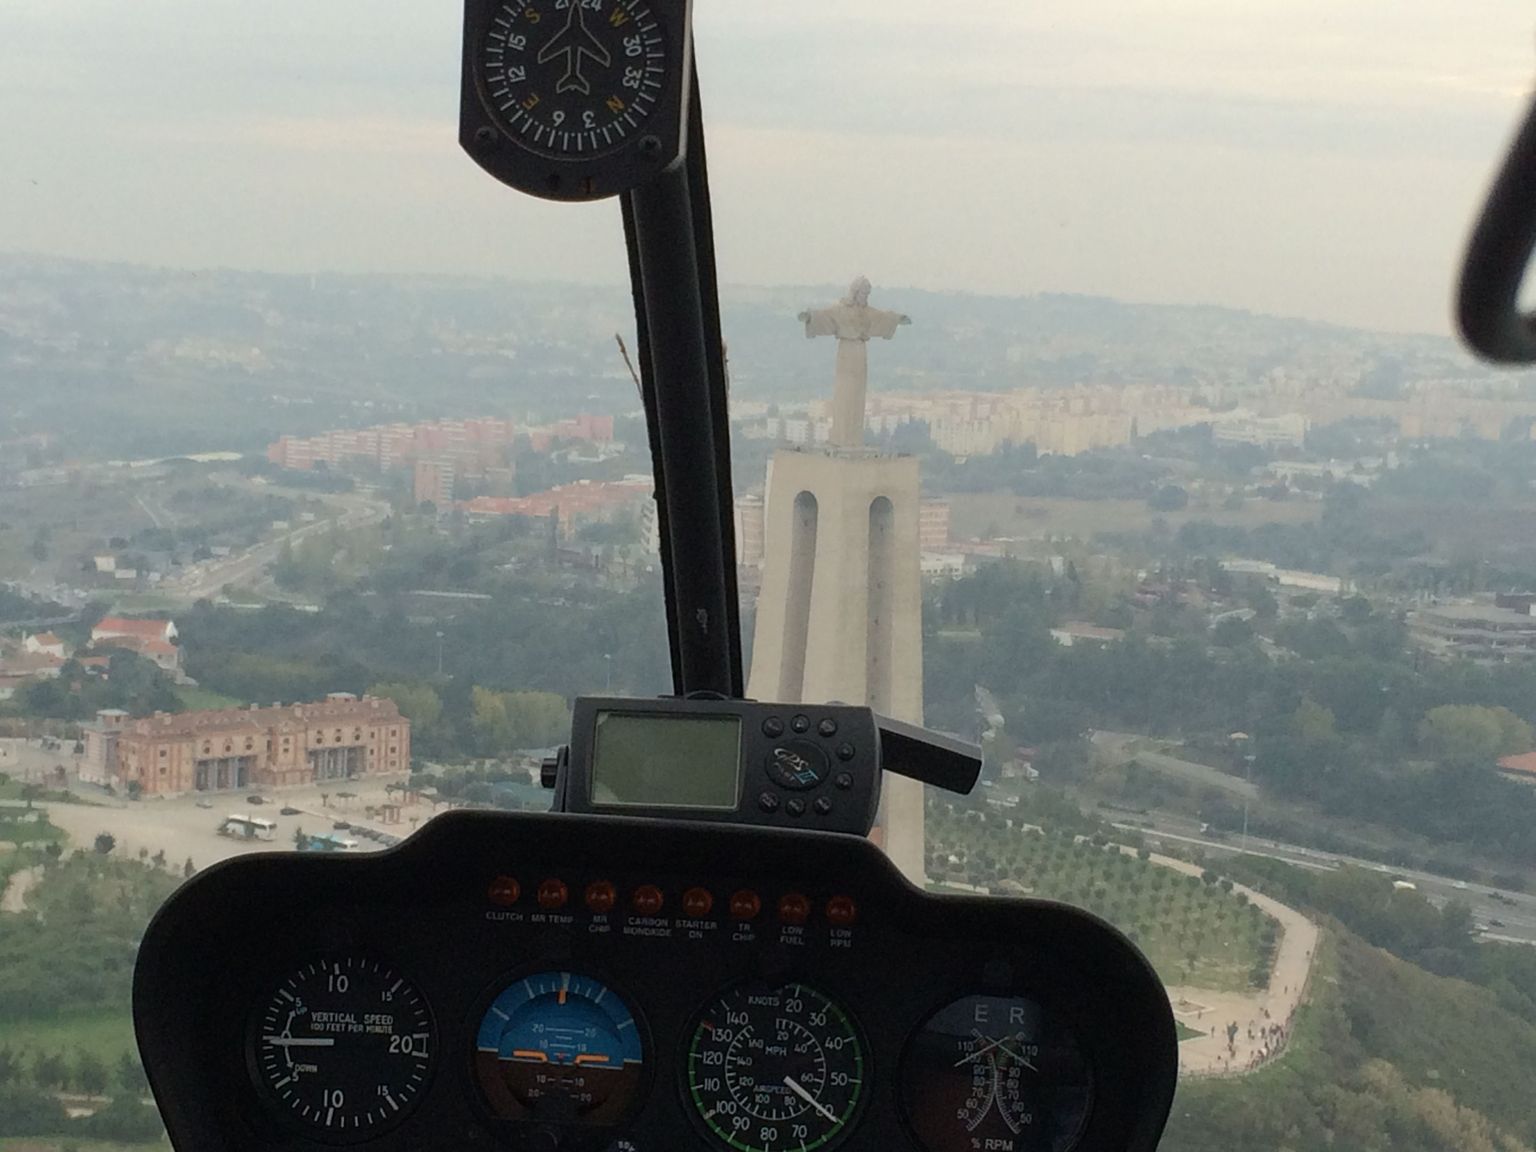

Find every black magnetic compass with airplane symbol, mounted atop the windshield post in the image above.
[459,0,690,200]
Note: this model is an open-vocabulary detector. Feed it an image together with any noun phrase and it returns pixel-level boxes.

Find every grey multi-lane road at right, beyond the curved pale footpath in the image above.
[1115,813,1536,945]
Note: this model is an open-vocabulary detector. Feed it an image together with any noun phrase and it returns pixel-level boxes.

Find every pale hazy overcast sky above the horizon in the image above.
[0,0,1536,332]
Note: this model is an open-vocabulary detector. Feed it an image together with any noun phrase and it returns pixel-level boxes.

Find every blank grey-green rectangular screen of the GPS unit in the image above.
[591,713,742,809]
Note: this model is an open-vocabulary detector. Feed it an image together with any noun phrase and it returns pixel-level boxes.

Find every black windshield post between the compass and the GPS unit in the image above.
[625,166,742,696]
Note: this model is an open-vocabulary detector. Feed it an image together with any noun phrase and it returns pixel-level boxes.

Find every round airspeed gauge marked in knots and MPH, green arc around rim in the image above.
[684,983,865,1152]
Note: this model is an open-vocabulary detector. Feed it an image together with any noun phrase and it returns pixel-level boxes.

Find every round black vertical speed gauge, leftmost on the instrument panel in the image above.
[249,957,436,1143]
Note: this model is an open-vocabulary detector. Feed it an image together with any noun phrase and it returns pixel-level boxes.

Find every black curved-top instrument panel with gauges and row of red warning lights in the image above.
[134,813,1177,1152]
